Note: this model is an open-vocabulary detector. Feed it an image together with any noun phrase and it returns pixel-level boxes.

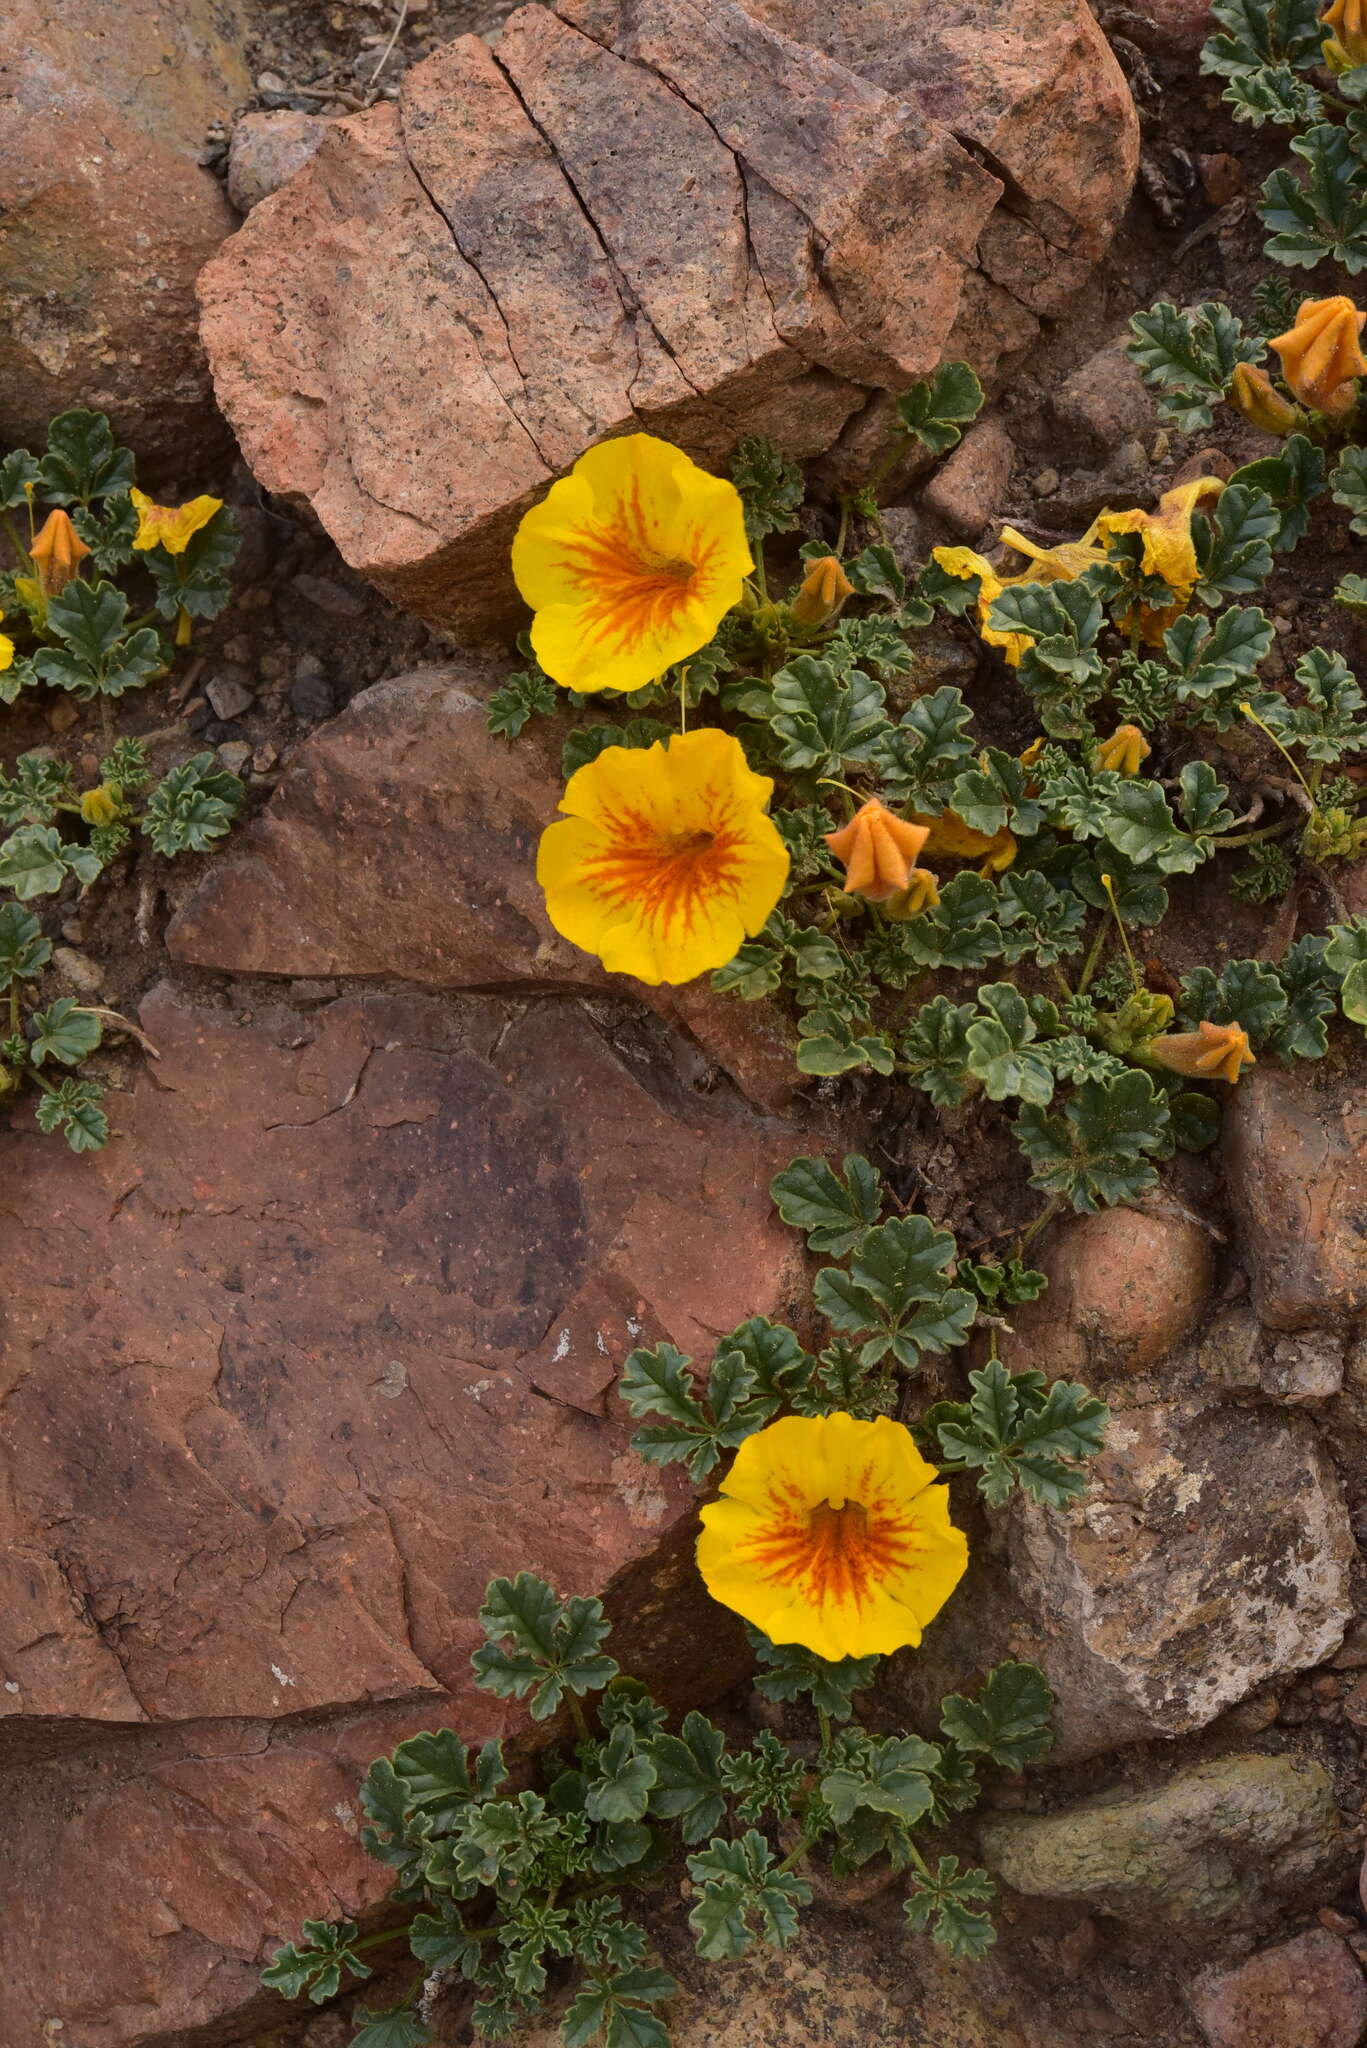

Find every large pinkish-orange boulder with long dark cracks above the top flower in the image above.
[201,0,1135,629]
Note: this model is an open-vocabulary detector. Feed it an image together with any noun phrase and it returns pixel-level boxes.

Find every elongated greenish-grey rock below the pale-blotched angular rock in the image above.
[980,1755,1349,1925]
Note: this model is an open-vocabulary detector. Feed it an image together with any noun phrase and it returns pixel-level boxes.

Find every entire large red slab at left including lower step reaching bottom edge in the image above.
[0,989,795,2048]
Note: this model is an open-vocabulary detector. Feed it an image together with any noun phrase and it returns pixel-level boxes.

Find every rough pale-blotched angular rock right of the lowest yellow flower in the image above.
[1008,1399,1355,1761]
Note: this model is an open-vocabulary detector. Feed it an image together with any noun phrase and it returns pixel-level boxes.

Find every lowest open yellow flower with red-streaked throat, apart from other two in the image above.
[697,1415,967,1663]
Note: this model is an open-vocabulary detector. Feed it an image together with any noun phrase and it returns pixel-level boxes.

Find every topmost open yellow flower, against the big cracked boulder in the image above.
[512,434,754,690]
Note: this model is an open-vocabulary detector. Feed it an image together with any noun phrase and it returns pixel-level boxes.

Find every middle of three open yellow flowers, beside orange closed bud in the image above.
[537,727,789,985]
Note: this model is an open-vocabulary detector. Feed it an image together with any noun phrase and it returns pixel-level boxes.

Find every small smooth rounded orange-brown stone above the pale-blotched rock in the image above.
[1008,1208,1215,1380]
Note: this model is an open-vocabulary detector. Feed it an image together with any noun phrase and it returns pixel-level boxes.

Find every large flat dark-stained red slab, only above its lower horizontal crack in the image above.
[0,989,797,1753]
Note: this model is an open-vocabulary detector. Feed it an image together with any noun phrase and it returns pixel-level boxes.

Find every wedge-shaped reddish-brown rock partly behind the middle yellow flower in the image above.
[168,659,801,1110]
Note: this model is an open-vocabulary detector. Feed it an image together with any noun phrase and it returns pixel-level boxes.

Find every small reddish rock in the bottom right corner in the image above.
[1191,1927,1367,2048]
